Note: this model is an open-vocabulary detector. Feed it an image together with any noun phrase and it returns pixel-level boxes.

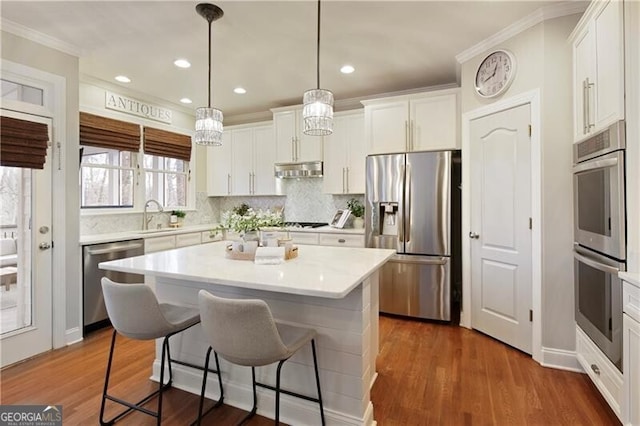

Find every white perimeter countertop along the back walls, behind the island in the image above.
[80,224,364,246]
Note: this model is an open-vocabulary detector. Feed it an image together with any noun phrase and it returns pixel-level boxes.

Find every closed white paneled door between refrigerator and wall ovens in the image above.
[469,104,532,354]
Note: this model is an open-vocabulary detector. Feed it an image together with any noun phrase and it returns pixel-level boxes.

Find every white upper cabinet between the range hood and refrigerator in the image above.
[322,110,368,194]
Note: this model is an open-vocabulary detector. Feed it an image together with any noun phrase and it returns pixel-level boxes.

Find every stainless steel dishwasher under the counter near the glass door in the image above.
[82,239,144,334]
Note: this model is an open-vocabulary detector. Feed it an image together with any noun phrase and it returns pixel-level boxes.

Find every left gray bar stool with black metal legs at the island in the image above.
[100,278,209,425]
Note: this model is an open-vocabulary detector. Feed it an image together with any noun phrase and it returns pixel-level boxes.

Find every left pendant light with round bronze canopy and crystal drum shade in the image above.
[193,3,224,146]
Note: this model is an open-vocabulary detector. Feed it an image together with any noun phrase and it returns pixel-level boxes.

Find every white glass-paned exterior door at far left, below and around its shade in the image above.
[0,110,53,367]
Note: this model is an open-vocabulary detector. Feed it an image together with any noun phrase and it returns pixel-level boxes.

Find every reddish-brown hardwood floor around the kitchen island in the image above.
[0,316,619,426]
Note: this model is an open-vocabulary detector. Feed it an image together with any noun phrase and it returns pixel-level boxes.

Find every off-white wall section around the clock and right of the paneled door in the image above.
[461,15,580,351]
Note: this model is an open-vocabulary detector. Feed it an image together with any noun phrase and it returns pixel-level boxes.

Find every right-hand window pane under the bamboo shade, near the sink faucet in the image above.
[144,154,189,208]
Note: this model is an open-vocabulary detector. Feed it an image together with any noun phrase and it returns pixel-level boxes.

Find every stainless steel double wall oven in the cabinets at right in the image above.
[573,121,626,370]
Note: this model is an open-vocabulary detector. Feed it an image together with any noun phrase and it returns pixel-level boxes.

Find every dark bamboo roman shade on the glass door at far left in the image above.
[0,116,49,169]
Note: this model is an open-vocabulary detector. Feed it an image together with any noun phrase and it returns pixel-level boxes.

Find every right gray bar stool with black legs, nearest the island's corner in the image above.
[196,290,325,425]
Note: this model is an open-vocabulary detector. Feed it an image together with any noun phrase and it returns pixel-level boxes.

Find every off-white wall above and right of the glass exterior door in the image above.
[1,32,82,339]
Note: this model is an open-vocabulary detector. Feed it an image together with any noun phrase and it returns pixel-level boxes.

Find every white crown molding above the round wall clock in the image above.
[456,1,588,64]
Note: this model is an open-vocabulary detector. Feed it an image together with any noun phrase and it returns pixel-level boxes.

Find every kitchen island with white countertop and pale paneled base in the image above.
[100,242,395,425]
